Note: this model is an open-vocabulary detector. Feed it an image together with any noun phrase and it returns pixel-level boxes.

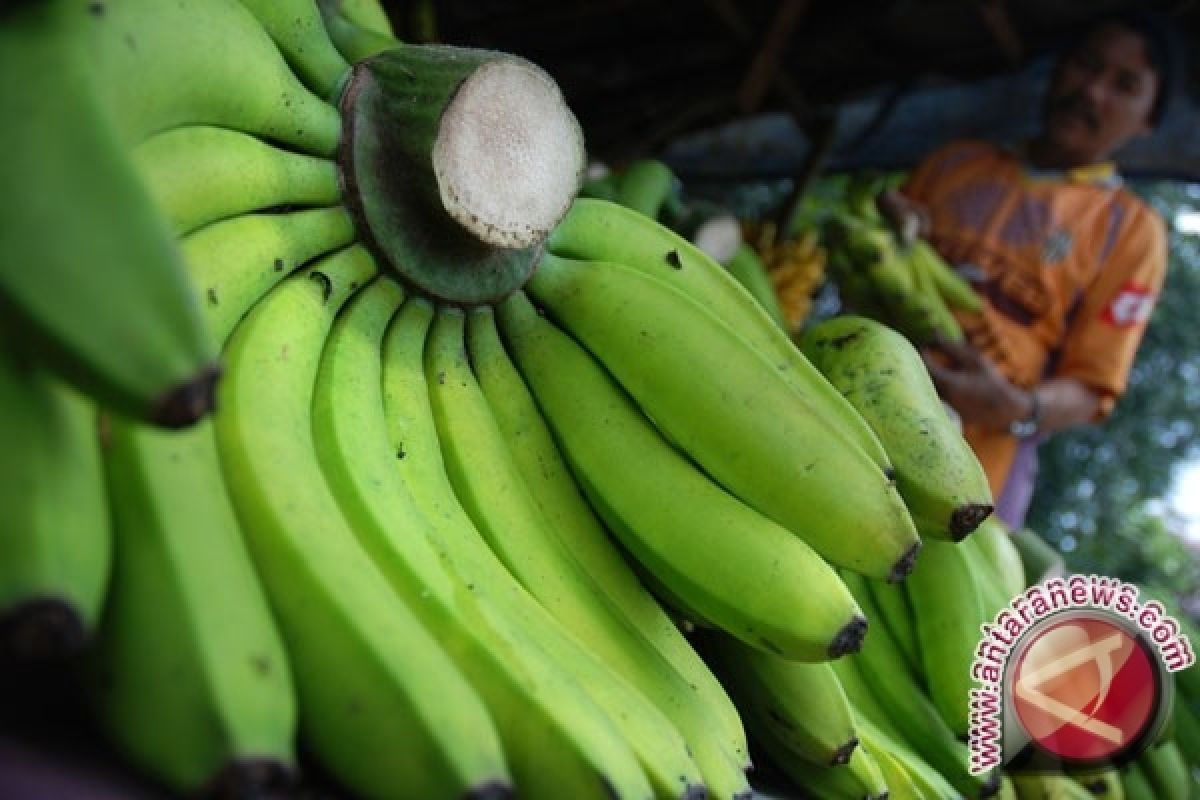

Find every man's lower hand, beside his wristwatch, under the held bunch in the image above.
[922,342,1033,431]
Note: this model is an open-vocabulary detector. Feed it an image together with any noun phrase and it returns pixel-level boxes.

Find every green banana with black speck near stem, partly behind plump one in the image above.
[546,198,892,482]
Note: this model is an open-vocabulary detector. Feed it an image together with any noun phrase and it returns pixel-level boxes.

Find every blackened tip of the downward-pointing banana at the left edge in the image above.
[0,597,88,664]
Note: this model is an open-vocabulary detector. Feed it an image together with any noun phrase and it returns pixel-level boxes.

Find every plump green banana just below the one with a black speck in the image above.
[527,254,920,579]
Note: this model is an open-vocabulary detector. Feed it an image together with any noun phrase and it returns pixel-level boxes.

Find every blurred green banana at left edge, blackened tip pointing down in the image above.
[0,350,112,662]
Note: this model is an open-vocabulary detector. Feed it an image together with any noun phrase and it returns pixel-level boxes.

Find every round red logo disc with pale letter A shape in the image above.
[1008,614,1163,763]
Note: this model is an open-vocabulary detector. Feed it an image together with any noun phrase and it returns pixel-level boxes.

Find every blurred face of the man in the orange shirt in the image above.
[1044,24,1158,166]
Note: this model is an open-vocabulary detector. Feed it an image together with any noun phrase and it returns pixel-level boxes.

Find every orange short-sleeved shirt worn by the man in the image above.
[904,142,1166,494]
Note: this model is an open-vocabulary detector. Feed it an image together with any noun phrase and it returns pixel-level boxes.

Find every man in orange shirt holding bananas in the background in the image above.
[878,12,1171,528]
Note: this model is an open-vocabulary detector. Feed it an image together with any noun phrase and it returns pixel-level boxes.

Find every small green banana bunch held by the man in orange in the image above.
[822,203,983,347]
